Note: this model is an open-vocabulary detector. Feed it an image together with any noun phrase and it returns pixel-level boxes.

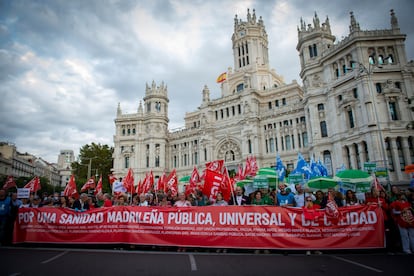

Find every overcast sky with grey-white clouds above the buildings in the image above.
[0,0,414,162]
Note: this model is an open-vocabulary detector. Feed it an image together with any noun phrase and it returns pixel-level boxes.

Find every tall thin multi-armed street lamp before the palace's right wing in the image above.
[351,56,390,190]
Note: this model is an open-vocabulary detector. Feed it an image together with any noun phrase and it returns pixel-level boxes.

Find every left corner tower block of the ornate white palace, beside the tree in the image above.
[113,81,169,180]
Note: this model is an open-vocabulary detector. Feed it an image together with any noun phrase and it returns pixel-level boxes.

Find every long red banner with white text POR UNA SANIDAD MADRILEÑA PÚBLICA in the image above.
[14,205,384,249]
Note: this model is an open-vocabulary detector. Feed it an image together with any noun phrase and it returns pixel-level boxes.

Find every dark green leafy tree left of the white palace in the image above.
[72,143,114,192]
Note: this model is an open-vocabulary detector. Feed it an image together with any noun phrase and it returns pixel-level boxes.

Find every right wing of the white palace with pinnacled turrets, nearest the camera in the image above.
[297,10,413,182]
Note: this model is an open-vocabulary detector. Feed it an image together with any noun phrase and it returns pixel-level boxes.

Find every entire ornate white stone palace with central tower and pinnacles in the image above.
[113,10,414,185]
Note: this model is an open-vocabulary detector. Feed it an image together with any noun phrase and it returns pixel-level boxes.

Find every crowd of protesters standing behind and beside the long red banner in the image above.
[0,183,414,254]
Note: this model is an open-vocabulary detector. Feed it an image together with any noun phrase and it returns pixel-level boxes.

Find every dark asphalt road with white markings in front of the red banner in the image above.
[0,247,414,276]
